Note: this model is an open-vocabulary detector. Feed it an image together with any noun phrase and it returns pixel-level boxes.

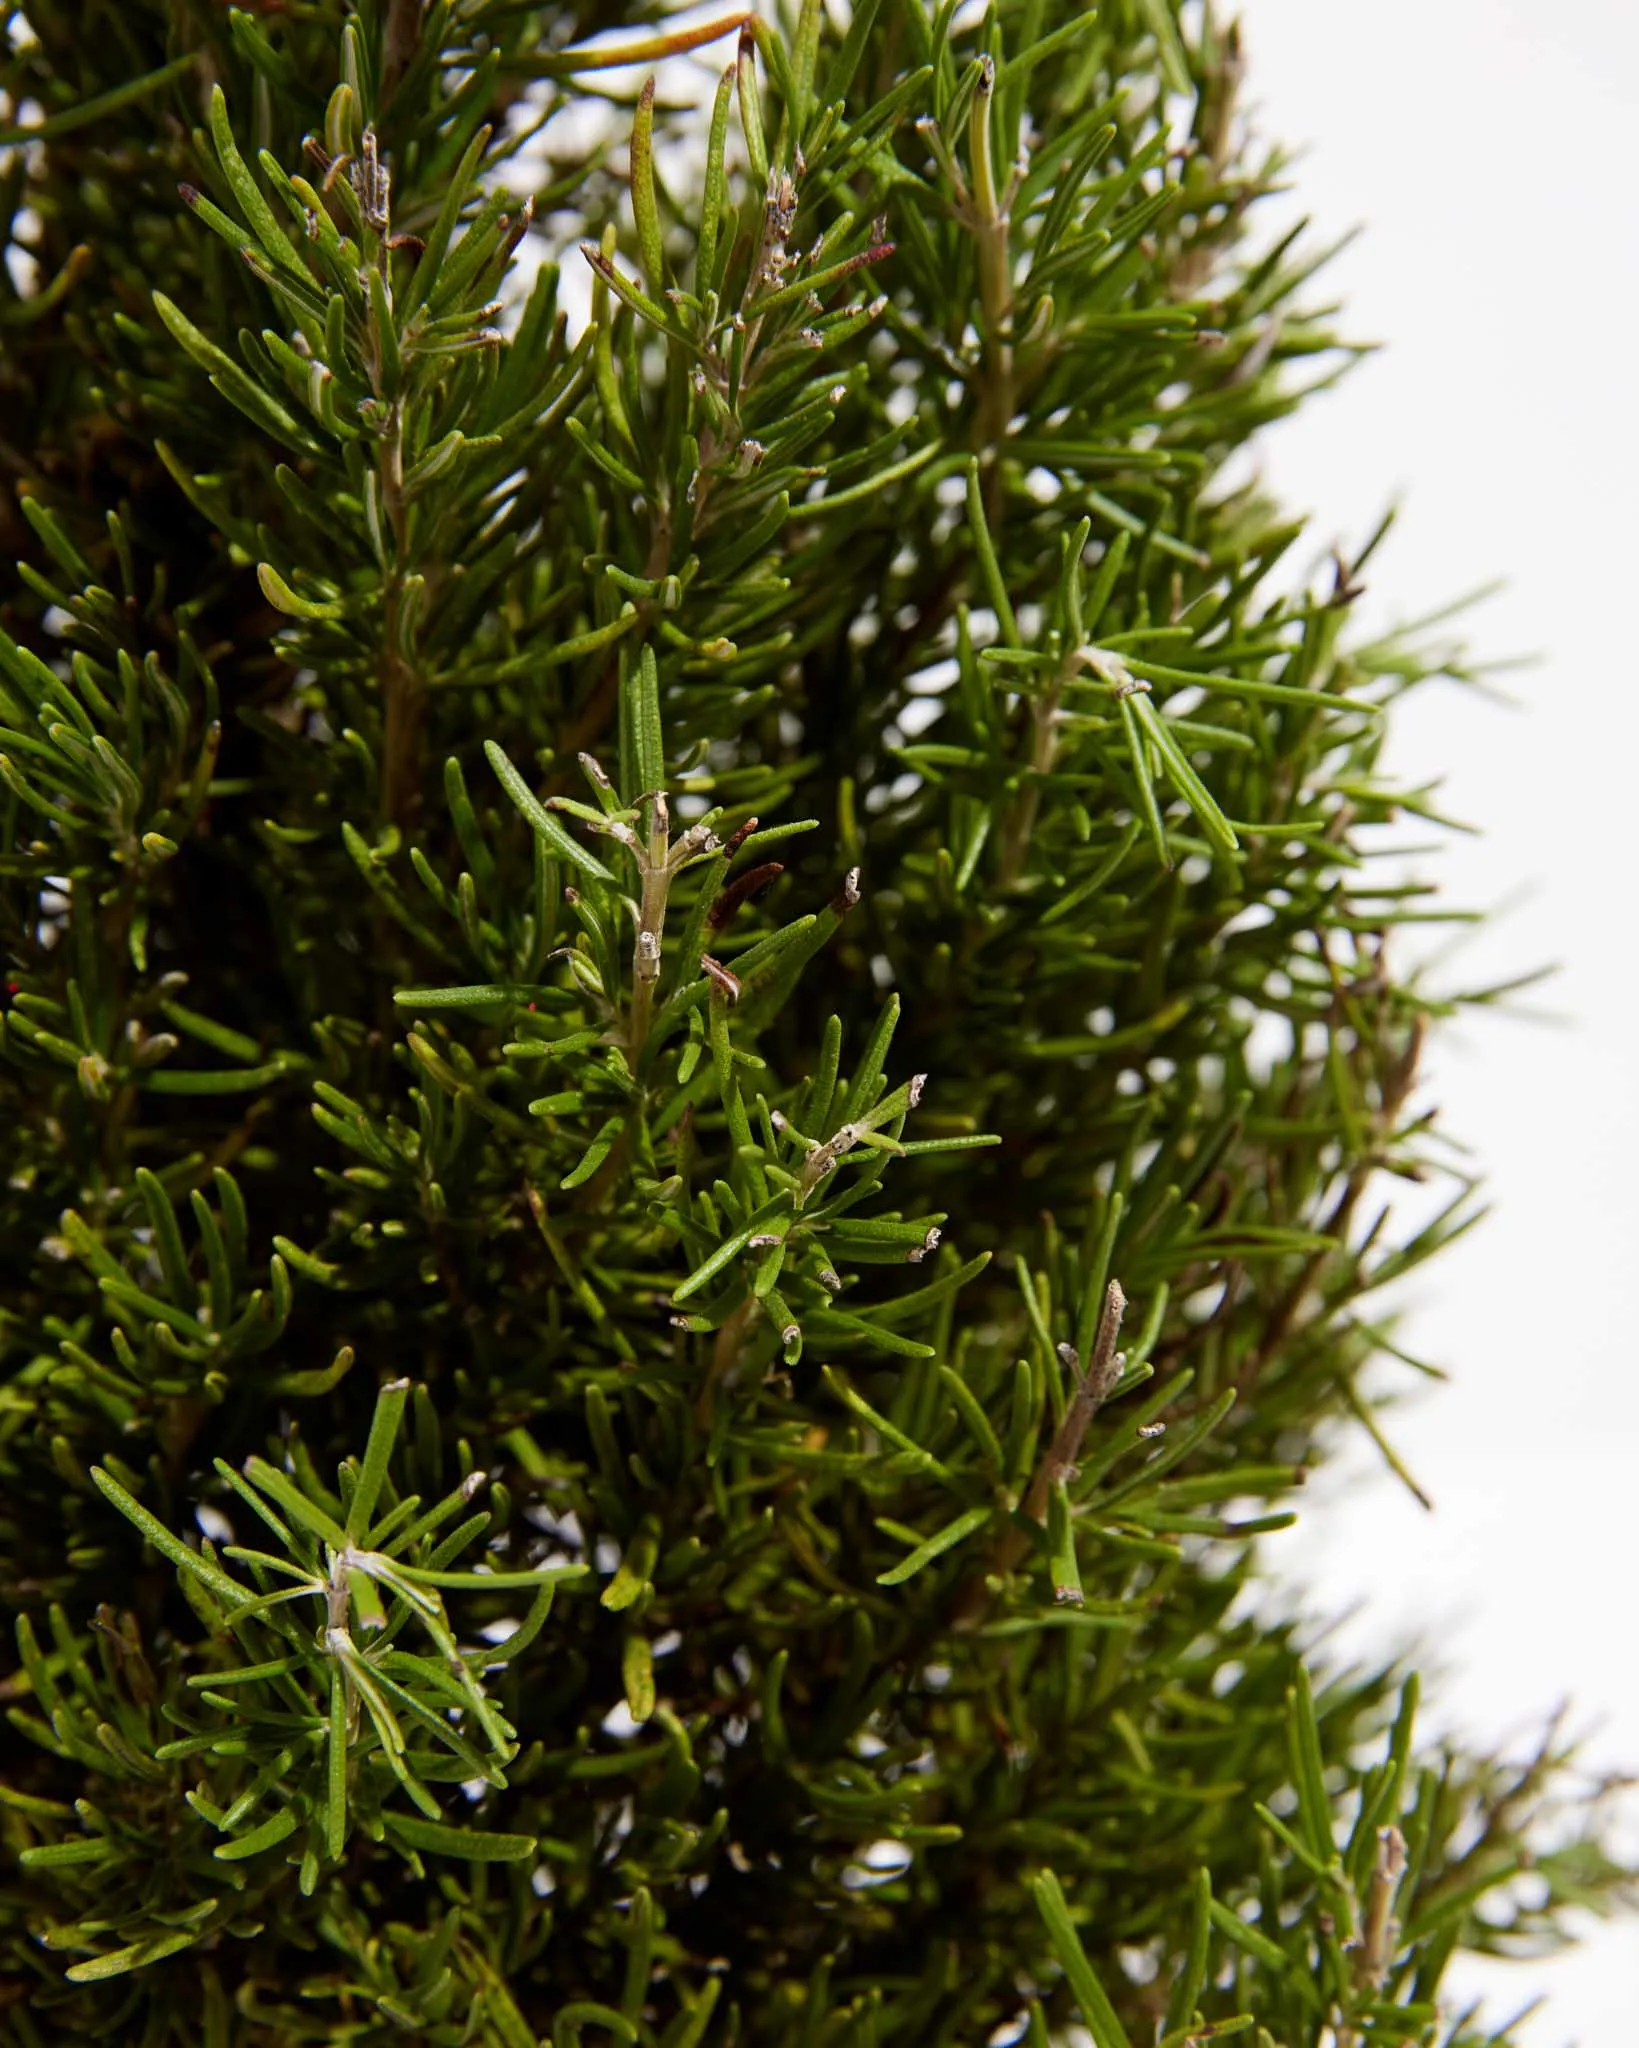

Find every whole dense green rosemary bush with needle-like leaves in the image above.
[0,0,1631,2048]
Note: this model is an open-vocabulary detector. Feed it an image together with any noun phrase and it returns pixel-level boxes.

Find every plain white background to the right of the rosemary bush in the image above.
[1221,0,1639,2048]
